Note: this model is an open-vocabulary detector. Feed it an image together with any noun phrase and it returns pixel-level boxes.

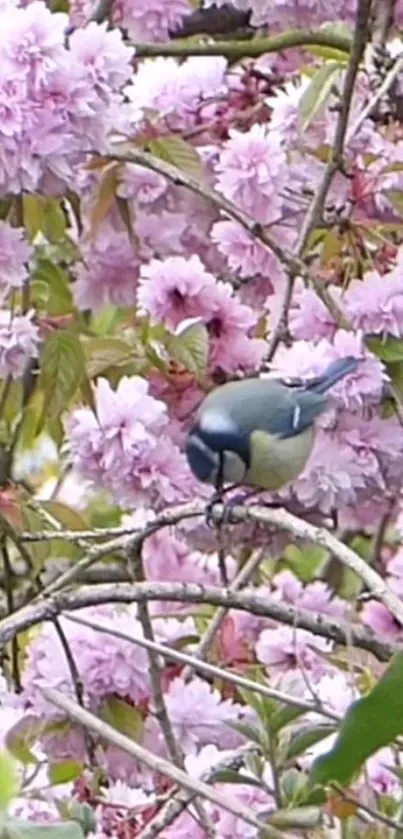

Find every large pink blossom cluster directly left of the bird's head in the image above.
[66,376,200,507]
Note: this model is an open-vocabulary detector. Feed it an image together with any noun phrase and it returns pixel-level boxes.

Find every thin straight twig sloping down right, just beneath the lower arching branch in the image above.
[63,612,340,722]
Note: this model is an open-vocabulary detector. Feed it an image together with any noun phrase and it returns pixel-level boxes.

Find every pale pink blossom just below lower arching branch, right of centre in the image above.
[256,626,332,678]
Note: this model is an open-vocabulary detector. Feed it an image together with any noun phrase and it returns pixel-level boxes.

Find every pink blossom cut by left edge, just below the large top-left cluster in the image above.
[0,221,33,296]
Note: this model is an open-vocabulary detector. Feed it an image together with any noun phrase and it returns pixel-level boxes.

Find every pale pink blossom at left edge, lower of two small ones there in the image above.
[0,309,39,379]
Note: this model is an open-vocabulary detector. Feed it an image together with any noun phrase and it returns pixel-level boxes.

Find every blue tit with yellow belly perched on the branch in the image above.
[186,357,359,492]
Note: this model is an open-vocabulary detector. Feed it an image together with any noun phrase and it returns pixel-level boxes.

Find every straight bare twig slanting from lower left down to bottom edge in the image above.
[41,688,285,839]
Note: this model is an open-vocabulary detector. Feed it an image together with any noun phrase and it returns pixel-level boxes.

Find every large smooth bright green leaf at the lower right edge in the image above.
[309,652,403,788]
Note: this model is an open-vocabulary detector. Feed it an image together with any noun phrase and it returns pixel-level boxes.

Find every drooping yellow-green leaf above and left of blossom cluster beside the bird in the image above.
[38,330,85,419]
